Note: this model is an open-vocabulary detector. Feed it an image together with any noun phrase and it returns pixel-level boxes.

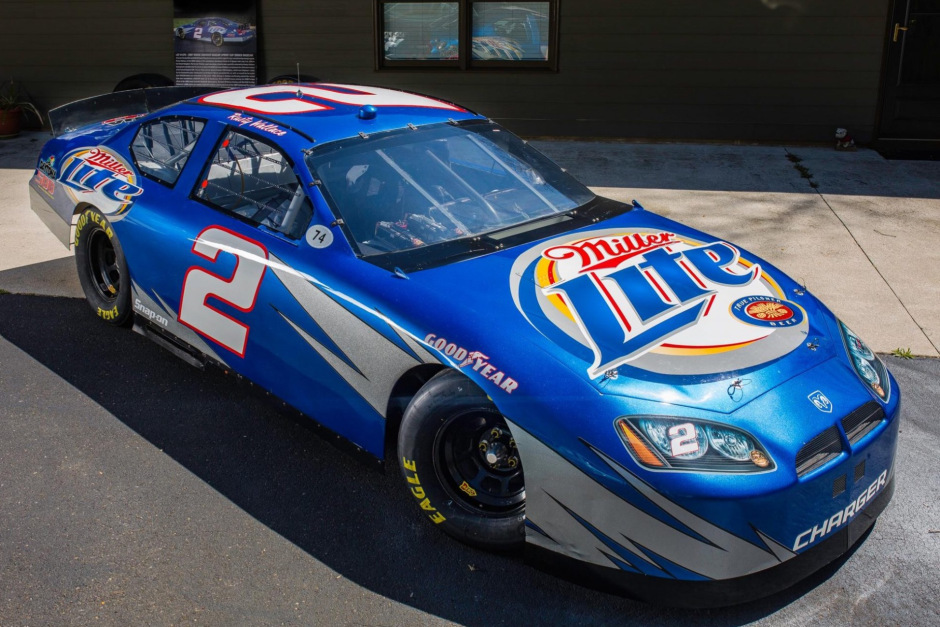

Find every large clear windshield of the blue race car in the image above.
[307,123,594,256]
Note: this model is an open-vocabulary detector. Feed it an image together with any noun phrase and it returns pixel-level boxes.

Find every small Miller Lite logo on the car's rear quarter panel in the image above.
[59,146,144,221]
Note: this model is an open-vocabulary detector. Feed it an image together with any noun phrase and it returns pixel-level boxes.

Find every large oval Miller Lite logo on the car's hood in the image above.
[510,229,808,378]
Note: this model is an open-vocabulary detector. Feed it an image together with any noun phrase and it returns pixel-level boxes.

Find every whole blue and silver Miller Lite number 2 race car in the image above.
[30,83,900,606]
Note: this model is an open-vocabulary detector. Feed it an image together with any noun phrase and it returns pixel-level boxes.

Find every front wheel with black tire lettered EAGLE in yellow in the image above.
[398,370,525,551]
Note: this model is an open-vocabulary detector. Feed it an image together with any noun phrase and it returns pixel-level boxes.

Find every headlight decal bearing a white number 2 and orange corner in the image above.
[616,416,776,473]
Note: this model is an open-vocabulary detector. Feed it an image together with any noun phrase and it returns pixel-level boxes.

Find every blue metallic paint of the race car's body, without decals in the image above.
[25,83,900,600]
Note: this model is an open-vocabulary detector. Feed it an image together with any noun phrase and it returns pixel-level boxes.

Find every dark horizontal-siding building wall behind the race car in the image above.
[0,0,889,141]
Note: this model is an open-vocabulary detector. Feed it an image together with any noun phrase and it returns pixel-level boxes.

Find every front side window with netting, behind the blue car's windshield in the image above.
[194,130,313,239]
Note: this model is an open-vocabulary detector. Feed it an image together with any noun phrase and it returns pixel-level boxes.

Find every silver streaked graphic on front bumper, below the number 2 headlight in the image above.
[507,416,802,579]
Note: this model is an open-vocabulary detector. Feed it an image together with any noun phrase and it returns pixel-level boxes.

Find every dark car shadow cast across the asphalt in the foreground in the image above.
[0,294,868,626]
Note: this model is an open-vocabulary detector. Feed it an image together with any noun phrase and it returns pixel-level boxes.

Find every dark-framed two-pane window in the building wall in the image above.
[375,0,558,69]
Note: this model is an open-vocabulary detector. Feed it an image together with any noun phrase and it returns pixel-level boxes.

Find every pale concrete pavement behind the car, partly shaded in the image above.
[0,133,940,357]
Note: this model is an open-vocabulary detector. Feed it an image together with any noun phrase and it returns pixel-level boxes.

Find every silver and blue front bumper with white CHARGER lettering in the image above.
[510,392,900,607]
